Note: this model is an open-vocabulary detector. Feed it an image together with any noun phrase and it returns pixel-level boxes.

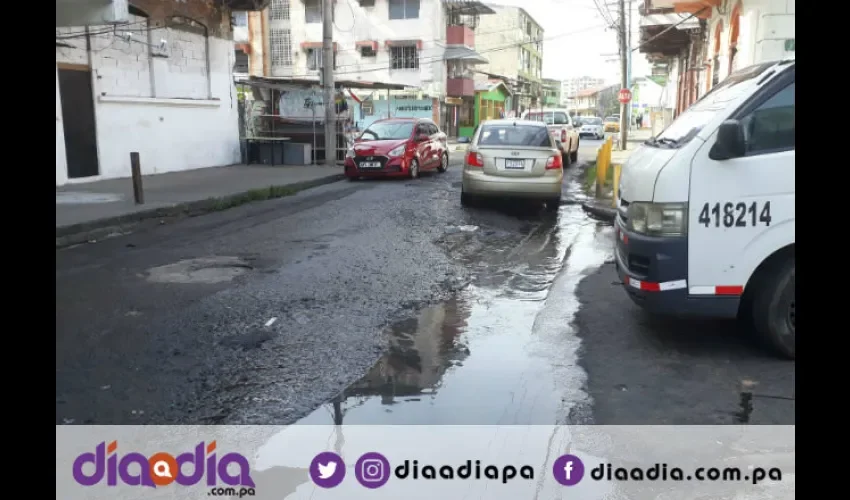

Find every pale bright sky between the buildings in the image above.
[487,0,649,83]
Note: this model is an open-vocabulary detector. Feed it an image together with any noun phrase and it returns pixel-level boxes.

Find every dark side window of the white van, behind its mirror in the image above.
[741,82,796,155]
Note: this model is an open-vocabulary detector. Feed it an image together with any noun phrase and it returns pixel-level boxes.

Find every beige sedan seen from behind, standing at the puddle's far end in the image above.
[460,119,564,211]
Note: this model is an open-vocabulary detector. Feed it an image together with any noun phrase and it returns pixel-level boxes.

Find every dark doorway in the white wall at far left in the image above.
[59,65,100,179]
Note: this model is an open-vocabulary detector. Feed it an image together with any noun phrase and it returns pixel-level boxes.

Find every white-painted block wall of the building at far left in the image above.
[56,16,240,185]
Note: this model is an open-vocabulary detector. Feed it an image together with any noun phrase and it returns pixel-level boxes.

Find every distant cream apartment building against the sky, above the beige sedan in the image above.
[476,5,544,114]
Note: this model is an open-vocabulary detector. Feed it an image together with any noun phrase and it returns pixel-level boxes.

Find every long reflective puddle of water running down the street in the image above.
[298,178,612,425]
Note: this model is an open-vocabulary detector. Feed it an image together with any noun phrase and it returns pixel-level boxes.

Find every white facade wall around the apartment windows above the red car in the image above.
[280,0,446,97]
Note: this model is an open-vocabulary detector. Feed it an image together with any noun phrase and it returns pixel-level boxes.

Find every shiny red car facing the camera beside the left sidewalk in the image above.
[345,118,449,181]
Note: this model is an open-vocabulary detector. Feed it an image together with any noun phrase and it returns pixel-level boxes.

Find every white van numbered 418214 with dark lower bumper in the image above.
[615,60,796,359]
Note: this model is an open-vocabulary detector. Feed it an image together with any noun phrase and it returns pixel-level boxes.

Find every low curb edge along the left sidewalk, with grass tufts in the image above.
[56,174,345,249]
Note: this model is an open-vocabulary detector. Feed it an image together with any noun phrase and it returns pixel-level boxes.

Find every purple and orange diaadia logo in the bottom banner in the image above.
[73,441,255,488]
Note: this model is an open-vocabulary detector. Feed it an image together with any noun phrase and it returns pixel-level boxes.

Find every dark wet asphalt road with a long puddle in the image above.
[56,141,794,424]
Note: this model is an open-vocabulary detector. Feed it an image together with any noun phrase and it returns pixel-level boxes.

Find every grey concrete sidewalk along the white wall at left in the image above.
[56,165,344,247]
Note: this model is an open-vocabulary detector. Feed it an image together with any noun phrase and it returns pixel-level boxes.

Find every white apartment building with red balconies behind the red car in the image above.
[236,0,494,135]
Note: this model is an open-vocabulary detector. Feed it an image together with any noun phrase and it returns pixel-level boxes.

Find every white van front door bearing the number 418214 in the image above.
[688,70,796,295]
